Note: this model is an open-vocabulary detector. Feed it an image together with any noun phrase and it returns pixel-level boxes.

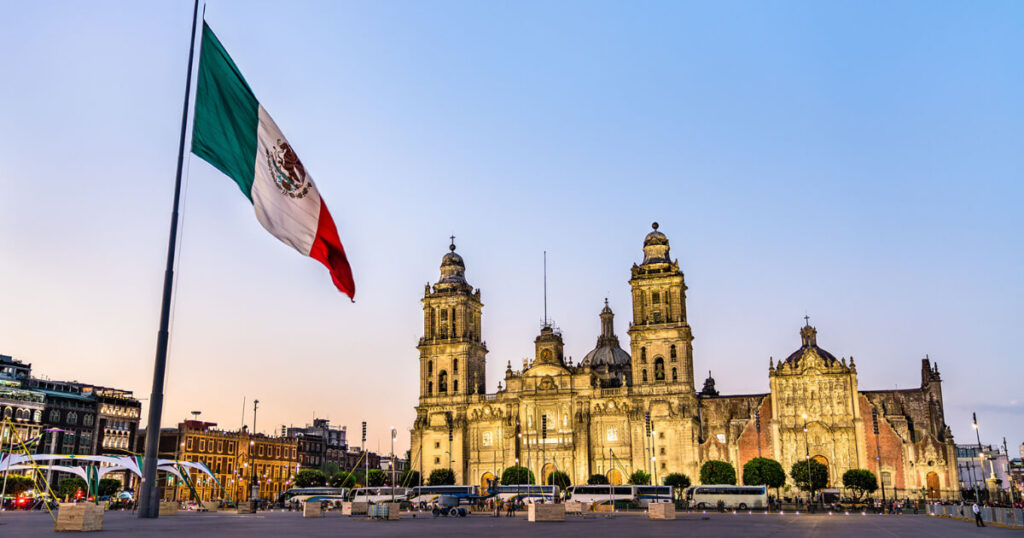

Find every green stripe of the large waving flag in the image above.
[193,23,259,202]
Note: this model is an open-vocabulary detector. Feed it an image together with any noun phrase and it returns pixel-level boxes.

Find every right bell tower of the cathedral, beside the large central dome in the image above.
[629,222,693,392]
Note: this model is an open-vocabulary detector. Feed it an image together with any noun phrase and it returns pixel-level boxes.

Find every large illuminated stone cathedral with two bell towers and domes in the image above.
[410,222,958,498]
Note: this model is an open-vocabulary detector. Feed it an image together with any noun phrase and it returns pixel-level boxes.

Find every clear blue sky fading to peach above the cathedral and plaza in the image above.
[0,0,1024,452]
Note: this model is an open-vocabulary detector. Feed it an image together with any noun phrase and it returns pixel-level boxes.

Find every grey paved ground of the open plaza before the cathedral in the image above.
[0,512,1022,538]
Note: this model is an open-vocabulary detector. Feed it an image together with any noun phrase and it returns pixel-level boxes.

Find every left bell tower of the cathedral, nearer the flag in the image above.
[418,237,487,403]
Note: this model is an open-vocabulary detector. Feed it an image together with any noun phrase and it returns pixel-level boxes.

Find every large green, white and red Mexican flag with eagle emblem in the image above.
[191,23,355,297]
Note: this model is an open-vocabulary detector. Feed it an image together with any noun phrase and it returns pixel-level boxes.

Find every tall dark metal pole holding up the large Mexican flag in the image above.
[138,0,199,519]
